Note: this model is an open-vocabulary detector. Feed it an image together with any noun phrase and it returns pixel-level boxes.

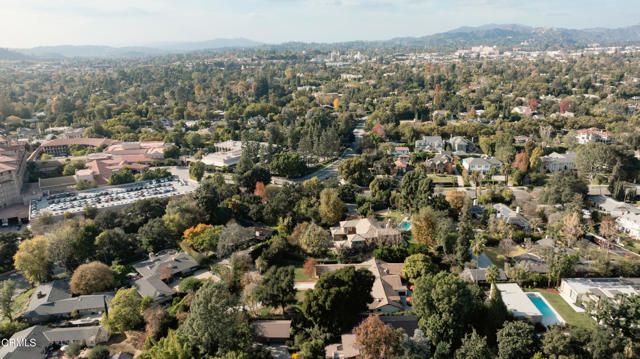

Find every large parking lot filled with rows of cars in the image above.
[29,176,197,219]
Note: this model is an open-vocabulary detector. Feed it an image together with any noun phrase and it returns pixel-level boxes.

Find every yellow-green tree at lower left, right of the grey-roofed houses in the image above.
[102,287,144,333]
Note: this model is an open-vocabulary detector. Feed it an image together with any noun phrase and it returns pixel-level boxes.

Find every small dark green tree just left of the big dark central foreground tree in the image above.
[255,266,296,313]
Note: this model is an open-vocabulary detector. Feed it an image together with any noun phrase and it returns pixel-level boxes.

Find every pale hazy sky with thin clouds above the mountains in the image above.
[0,0,640,48]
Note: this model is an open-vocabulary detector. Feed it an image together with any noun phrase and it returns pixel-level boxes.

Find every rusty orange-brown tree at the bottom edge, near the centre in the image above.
[353,315,400,359]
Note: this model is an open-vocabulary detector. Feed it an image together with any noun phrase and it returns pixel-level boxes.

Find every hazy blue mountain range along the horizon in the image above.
[0,24,640,60]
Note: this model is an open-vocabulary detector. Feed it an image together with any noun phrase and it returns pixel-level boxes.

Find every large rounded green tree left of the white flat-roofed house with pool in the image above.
[413,272,477,347]
